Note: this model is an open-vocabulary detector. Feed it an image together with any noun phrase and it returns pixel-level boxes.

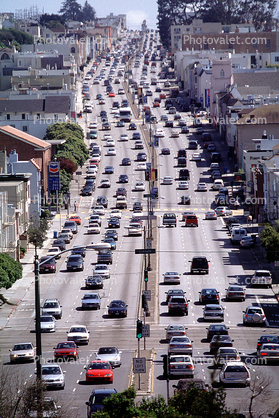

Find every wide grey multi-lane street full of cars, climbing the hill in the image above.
[0,31,279,418]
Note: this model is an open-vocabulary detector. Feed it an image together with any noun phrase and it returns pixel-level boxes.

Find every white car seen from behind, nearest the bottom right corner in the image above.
[219,361,251,386]
